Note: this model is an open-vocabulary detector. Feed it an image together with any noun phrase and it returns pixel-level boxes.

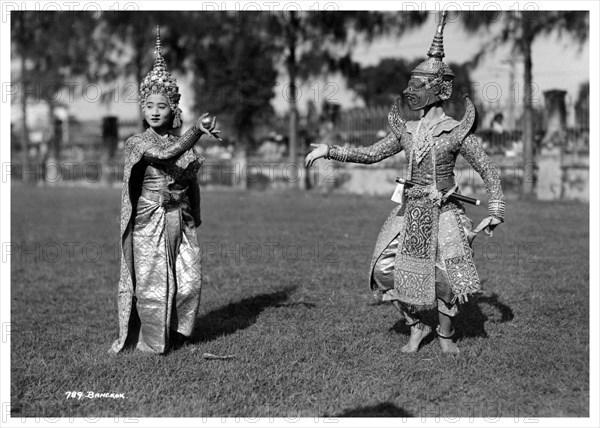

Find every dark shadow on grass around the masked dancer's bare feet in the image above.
[390,293,515,345]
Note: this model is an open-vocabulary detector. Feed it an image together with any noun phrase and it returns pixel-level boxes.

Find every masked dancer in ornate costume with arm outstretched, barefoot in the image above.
[306,13,505,354]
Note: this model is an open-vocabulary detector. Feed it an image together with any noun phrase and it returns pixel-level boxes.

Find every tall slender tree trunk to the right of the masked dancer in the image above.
[521,15,536,199]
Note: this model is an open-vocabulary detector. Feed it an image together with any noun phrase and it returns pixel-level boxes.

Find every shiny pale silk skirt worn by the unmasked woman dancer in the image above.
[133,196,202,353]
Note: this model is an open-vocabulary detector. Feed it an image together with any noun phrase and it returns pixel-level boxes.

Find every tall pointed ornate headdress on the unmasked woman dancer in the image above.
[139,25,181,128]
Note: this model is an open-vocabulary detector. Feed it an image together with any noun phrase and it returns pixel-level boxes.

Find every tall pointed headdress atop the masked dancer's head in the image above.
[411,11,454,99]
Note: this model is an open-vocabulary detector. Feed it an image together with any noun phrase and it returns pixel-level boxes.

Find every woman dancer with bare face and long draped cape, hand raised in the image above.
[110,28,219,354]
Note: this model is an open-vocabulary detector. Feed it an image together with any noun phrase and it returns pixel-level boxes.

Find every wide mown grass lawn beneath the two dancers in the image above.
[11,184,590,421]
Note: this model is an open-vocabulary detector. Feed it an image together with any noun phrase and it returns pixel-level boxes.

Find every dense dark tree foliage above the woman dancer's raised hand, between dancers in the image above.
[188,12,279,147]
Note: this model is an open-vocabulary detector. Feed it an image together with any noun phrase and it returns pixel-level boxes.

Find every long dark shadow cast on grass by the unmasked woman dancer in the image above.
[190,287,296,343]
